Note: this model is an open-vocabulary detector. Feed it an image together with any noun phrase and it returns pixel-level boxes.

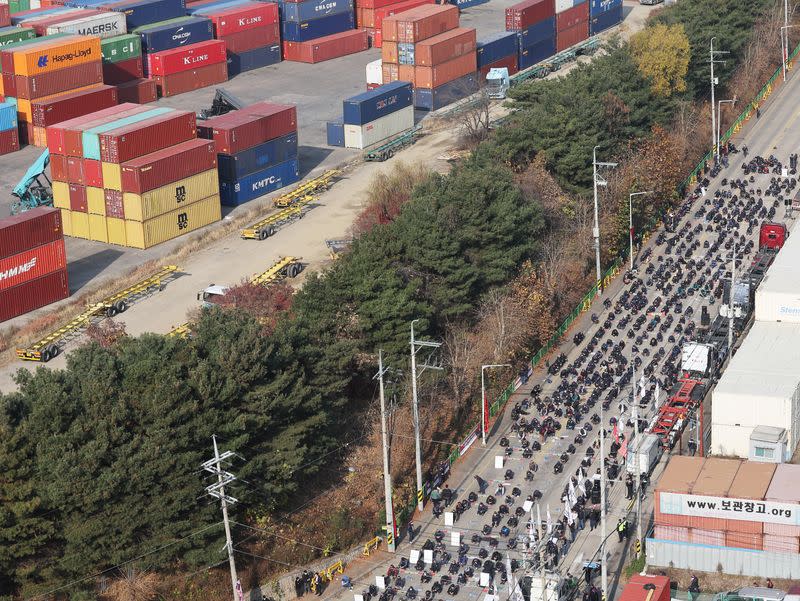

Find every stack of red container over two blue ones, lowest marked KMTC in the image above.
[198,102,300,206]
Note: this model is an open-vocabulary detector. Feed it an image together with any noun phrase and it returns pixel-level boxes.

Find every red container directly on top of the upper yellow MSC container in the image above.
[122,139,217,194]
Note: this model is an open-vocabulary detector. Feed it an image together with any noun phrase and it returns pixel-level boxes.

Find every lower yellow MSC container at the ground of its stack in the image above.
[125,194,222,248]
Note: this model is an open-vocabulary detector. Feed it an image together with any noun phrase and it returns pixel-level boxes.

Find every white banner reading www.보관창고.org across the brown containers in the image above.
[659,492,800,526]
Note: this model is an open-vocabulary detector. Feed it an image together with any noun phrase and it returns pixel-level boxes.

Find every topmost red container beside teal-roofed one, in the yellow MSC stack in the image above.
[99,111,197,164]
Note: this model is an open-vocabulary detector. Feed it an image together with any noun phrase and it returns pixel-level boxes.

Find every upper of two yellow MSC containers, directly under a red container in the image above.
[122,169,219,223]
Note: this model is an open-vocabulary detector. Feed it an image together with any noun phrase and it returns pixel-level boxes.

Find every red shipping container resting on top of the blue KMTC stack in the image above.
[197,102,297,154]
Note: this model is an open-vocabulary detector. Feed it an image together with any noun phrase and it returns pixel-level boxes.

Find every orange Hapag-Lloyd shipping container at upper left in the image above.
[14,35,102,77]
